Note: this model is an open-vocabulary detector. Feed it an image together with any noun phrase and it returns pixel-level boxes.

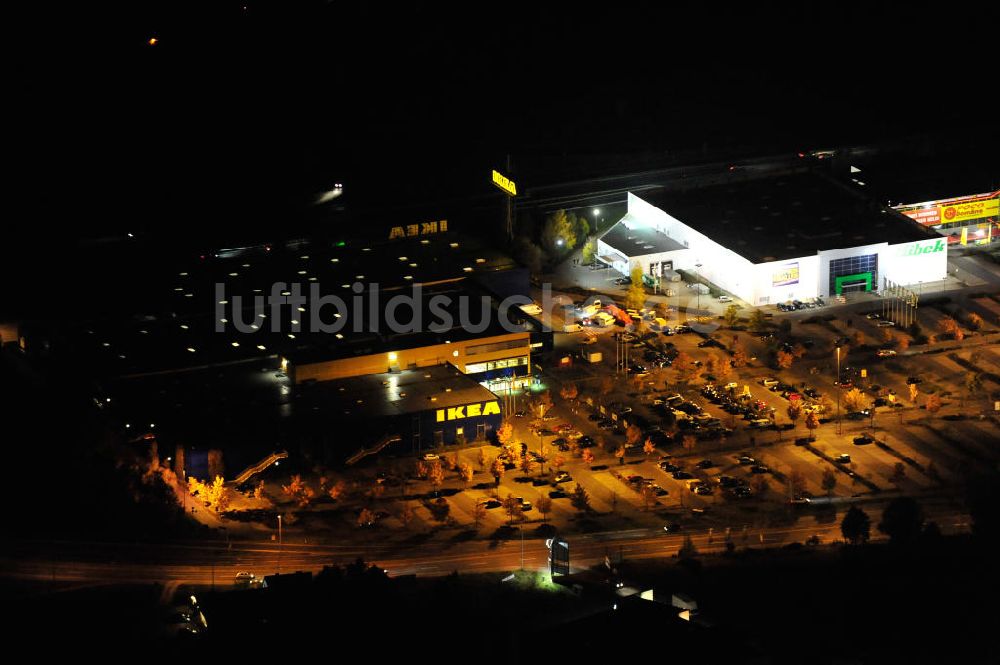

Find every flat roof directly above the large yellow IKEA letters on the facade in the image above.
[299,363,496,420]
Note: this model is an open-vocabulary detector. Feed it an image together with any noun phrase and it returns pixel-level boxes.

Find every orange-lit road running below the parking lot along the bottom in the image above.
[0,497,968,588]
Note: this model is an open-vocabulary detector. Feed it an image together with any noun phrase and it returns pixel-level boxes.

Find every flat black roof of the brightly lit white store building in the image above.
[649,170,937,263]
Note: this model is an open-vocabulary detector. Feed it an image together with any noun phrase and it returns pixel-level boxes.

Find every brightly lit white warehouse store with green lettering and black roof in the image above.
[597,171,948,305]
